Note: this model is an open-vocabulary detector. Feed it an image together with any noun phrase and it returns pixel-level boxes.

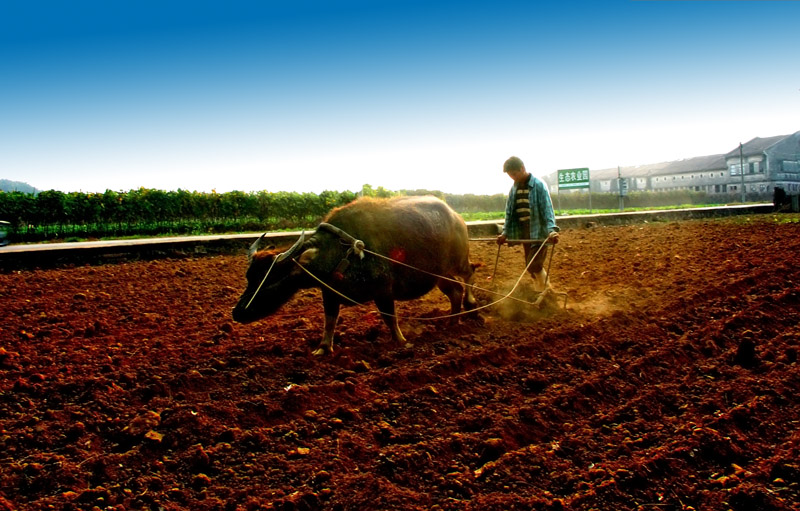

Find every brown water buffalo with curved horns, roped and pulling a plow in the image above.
[233,197,475,355]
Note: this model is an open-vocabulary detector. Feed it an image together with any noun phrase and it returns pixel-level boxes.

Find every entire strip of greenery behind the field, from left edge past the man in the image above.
[0,185,736,242]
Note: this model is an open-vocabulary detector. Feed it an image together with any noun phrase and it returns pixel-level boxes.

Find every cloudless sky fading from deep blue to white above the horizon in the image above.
[0,0,800,194]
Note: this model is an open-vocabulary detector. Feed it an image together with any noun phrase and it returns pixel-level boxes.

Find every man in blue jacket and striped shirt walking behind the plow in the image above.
[497,156,558,292]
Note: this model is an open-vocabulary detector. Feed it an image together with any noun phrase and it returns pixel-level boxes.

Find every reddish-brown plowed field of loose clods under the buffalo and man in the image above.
[0,215,800,511]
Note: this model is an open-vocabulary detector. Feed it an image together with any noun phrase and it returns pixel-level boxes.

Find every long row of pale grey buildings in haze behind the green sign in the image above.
[544,131,800,198]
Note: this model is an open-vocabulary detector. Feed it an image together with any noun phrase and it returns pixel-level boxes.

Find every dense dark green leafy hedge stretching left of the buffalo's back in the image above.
[0,188,356,241]
